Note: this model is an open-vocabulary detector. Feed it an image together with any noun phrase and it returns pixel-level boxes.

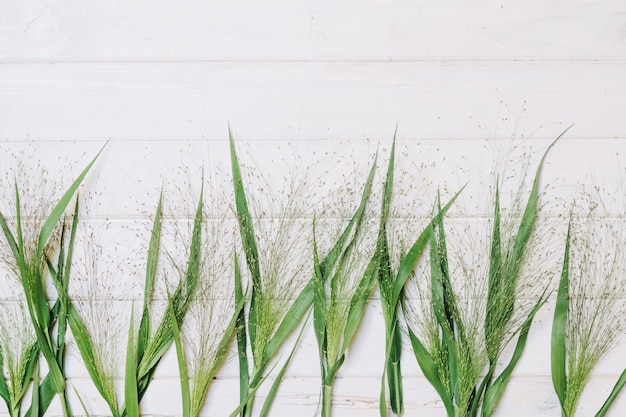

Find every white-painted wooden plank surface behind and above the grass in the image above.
[0,0,626,417]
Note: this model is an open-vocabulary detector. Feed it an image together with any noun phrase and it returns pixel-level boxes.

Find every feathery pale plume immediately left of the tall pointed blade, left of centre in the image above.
[166,178,243,417]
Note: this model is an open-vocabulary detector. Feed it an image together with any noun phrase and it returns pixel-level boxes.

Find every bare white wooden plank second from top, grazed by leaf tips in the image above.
[0,62,626,141]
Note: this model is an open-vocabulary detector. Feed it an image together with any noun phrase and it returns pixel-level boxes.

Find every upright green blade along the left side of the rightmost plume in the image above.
[550,223,570,407]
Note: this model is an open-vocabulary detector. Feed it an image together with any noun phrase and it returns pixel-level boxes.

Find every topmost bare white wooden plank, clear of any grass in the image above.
[0,0,626,62]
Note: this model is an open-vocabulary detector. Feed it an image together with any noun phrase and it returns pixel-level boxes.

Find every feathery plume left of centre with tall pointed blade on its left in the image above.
[229,132,358,417]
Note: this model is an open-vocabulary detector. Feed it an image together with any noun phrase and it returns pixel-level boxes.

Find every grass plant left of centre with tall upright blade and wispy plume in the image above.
[229,130,326,417]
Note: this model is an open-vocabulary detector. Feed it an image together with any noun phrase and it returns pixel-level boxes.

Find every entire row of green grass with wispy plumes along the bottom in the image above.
[0,128,626,417]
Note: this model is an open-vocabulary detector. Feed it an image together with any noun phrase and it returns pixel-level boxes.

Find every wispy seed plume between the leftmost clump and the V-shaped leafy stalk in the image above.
[66,200,133,415]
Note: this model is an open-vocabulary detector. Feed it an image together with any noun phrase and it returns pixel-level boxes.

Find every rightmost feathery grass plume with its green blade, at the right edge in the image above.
[551,189,626,417]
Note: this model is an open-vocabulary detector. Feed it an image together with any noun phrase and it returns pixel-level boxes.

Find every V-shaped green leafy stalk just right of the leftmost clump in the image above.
[60,189,203,417]
